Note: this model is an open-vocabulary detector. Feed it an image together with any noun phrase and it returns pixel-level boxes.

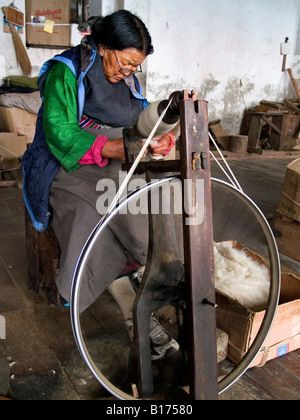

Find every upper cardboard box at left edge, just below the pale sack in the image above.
[0,106,37,143]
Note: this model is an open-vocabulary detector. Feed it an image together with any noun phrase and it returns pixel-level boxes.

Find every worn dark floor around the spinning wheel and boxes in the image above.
[0,155,300,400]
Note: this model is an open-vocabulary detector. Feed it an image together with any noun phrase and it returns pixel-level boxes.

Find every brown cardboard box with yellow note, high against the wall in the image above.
[26,0,71,47]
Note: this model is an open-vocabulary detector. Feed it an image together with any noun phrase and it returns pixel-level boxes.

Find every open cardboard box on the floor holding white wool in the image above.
[216,243,300,366]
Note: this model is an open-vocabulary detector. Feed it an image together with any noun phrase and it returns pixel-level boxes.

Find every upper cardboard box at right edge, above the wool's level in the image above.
[278,158,300,222]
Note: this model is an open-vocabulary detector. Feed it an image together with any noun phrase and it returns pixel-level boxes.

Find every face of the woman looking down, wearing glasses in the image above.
[99,45,146,83]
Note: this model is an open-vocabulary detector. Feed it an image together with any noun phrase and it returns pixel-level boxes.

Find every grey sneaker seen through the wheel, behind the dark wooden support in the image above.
[125,315,179,360]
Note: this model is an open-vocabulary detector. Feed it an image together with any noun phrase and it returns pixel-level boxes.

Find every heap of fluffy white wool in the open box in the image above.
[214,242,270,312]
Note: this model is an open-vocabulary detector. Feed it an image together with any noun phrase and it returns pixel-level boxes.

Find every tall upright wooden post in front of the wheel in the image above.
[180,92,218,400]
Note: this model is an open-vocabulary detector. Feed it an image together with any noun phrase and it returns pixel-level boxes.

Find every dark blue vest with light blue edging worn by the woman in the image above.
[22,37,148,232]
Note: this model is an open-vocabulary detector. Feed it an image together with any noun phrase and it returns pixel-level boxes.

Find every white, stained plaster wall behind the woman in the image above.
[0,0,300,133]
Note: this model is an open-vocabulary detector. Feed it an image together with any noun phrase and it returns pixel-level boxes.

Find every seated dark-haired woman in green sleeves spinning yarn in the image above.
[23,10,178,358]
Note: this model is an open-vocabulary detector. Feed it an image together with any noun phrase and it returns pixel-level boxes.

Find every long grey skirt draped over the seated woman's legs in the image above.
[50,153,148,310]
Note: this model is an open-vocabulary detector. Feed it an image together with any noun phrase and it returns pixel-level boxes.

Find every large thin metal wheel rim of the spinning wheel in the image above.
[70,177,281,400]
